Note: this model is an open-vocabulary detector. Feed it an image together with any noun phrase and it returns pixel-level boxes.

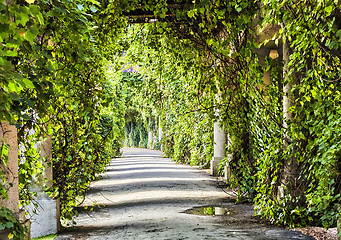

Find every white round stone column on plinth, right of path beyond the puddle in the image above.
[211,120,226,176]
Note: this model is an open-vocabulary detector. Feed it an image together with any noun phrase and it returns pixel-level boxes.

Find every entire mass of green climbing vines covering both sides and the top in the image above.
[0,0,341,237]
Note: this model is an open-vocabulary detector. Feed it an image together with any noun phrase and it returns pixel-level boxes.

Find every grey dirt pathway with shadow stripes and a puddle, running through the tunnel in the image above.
[57,148,312,240]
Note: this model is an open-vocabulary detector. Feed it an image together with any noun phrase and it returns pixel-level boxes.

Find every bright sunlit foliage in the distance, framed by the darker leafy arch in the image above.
[116,25,213,167]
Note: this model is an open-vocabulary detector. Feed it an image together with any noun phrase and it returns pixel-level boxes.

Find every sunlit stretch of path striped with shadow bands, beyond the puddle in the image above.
[82,149,220,207]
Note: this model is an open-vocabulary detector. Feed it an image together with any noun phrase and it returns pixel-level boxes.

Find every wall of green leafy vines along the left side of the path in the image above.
[0,1,124,233]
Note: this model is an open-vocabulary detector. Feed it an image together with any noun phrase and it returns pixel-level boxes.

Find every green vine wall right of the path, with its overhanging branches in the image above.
[115,0,341,231]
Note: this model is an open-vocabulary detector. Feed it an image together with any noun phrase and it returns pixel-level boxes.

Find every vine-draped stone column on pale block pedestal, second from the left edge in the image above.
[27,136,60,238]
